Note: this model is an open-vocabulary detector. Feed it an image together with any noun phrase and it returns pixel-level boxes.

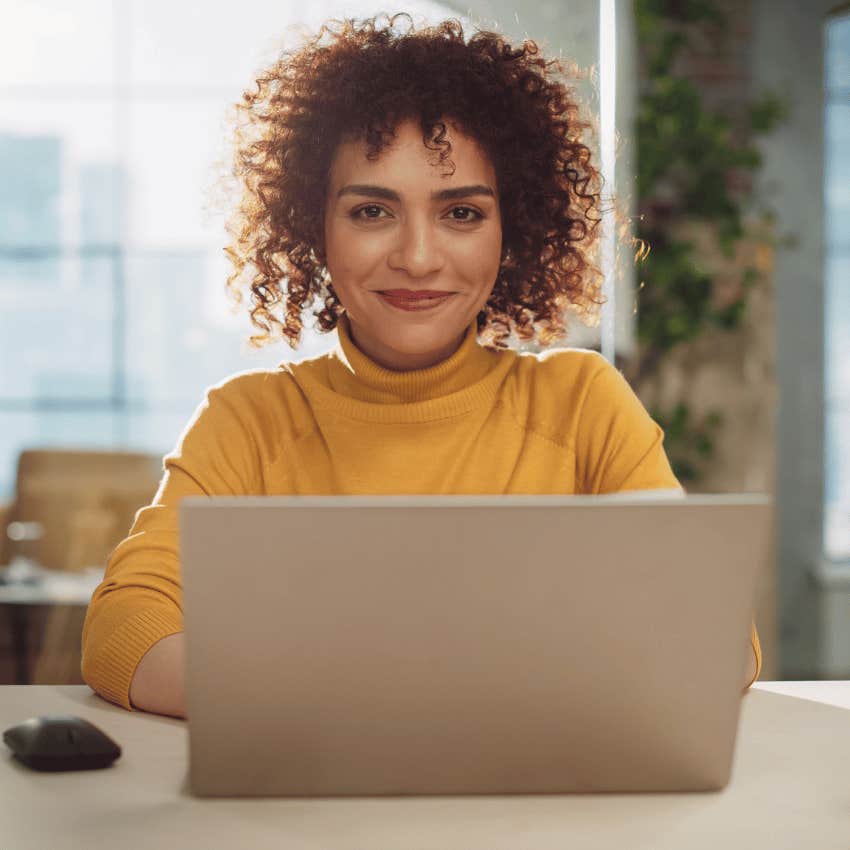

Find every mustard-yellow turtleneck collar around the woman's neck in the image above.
[328,313,493,404]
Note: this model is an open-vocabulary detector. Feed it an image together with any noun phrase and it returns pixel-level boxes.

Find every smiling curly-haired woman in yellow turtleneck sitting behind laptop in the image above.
[82,16,760,717]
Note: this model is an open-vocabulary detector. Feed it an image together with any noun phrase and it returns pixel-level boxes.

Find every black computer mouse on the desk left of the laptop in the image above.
[3,714,121,770]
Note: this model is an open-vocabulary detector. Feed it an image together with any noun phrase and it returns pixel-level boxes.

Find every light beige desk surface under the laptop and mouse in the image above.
[0,682,850,850]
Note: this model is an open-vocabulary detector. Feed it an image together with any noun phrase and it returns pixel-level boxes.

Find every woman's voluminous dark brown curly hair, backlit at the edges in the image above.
[219,13,605,349]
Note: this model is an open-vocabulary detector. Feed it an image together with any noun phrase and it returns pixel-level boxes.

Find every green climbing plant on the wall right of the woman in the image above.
[618,0,788,484]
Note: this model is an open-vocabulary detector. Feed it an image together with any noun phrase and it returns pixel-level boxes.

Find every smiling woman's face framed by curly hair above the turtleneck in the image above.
[325,121,502,371]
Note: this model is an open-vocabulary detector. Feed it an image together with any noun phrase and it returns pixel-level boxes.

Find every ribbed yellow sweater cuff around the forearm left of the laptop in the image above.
[86,608,183,711]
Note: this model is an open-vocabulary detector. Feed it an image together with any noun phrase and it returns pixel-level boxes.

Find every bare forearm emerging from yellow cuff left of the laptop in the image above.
[130,632,186,717]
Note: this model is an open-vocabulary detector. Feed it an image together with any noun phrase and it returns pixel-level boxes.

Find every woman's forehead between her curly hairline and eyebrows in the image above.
[329,121,496,190]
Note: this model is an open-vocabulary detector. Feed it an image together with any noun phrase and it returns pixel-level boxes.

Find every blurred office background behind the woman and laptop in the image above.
[0,0,850,683]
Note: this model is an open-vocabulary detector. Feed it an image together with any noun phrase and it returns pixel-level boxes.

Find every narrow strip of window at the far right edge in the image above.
[824,7,850,562]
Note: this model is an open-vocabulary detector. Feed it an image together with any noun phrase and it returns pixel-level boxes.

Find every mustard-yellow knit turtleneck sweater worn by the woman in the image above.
[82,316,761,709]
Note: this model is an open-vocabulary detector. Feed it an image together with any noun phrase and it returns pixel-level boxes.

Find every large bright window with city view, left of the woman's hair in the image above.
[0,0,458,499]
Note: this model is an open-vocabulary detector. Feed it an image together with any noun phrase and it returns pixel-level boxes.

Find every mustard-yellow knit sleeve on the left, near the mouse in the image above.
[82,383,261,710]
